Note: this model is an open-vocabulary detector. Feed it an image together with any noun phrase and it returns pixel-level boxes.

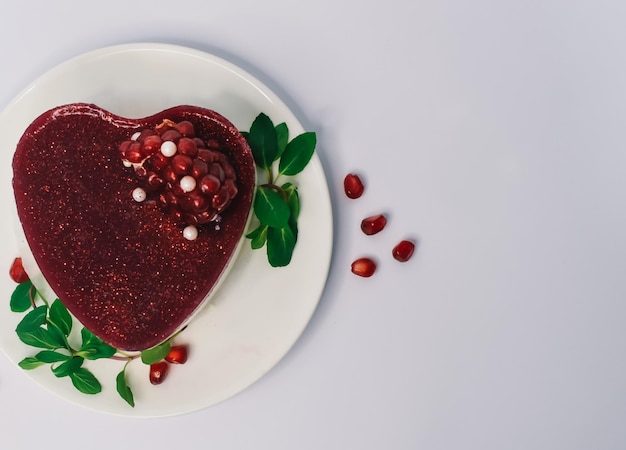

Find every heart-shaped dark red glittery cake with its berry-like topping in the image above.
[13,103,256,351]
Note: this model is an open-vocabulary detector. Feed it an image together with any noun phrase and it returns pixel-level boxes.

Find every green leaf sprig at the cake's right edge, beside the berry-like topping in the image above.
[242,113,317,267]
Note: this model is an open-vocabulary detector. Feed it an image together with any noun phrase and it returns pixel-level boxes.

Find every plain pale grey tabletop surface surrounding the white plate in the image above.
[0,0,626,450]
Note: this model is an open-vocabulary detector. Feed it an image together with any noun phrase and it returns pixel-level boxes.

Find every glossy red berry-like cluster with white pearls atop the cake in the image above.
[119,120,238,240]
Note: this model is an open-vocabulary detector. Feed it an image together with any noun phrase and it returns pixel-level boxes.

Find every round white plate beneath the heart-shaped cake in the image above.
[0,44,332,417]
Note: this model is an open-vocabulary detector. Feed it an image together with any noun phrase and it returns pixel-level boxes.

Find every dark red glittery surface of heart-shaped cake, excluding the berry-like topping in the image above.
[13,104,255,350]
